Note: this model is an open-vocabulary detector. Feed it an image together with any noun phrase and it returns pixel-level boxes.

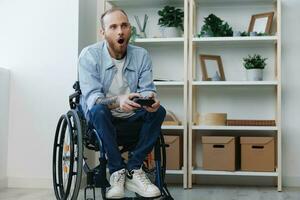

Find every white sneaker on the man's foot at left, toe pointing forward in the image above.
[106,169,125,199]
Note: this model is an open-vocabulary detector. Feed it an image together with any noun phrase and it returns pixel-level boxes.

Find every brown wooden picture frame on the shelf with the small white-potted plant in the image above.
[199,54,225,81]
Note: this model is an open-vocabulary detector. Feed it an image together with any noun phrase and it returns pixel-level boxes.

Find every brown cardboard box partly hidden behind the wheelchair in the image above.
[164,135,183,170]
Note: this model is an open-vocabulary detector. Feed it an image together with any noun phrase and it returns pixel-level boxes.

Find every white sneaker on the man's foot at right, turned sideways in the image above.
[125,169,160,197]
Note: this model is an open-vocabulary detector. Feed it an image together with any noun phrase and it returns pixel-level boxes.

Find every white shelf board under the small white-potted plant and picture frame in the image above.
[192,81,278,86]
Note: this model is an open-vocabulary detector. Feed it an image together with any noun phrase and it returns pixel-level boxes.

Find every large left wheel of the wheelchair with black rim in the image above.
[52,110,83,200]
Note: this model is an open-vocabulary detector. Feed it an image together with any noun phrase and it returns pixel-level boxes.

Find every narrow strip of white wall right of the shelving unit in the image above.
[282,0,300,186]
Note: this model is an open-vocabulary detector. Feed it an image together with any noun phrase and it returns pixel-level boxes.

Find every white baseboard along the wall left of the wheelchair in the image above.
[7,177,53,189]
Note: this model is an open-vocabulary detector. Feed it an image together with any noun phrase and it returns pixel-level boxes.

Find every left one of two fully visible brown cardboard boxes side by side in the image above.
[202,136,236,171]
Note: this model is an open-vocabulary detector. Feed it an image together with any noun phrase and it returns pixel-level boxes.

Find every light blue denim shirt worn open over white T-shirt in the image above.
[78,41,156,116]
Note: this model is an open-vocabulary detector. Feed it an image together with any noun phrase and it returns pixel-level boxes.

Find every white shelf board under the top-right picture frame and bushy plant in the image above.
[192,36,278,45]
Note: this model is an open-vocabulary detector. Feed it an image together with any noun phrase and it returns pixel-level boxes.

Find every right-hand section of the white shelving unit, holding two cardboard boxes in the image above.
[188,0,282,191]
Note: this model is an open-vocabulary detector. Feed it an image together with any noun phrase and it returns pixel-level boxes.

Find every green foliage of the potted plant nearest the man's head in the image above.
[157,6,184,30]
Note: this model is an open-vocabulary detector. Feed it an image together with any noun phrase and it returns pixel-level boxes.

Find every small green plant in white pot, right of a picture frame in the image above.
[243,54,267,81]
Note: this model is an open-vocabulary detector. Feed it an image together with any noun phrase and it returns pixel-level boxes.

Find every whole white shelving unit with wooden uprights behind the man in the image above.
[100,0,282,191]
